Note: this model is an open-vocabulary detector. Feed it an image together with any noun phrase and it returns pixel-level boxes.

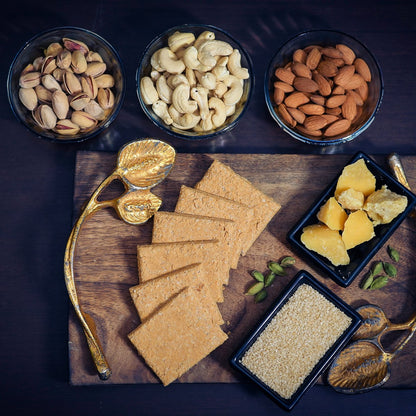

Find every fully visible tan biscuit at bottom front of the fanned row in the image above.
[128,287,228,386]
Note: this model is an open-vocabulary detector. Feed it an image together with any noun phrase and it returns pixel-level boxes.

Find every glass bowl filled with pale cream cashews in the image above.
[136,24,254,140]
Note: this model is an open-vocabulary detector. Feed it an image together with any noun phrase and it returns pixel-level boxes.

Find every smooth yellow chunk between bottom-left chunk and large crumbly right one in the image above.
[342,210,375,250]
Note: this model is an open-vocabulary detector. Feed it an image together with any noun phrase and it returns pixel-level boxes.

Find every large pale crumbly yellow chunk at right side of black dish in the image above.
[364,185,407,225]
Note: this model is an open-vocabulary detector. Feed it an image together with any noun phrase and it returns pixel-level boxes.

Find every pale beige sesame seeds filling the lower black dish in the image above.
[241,284,351,399]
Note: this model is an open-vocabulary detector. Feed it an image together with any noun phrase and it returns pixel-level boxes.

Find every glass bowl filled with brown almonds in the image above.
[264,30,384,146]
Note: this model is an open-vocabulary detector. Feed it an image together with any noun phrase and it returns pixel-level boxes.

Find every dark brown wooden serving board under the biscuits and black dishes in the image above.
[69,152,416,387]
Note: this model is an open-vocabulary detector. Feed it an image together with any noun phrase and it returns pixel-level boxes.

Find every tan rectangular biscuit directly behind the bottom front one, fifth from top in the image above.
[130,263,224,324]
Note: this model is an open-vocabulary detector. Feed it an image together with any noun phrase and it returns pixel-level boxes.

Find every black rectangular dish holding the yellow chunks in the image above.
[287,152,416,287]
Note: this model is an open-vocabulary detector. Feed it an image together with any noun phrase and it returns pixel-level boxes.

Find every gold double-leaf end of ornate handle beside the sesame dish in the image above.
[328,305,416,394]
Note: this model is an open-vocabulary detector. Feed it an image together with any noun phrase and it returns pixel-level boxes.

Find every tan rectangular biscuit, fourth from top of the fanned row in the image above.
[137,240,230,302]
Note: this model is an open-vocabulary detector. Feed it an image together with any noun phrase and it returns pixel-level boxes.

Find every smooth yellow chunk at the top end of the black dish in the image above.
[335,159,376,199]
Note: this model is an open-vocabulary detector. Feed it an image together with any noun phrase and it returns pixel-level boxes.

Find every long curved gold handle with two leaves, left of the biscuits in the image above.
[64,139,176,380]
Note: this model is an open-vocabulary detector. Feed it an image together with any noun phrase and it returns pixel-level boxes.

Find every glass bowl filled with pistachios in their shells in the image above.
[7,27,125,142]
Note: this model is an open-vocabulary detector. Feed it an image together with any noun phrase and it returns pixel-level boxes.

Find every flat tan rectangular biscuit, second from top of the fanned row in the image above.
[175,185,253,262]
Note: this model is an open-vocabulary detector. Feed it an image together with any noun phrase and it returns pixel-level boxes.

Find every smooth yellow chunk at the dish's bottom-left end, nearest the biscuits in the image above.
[300,224,350,266]
